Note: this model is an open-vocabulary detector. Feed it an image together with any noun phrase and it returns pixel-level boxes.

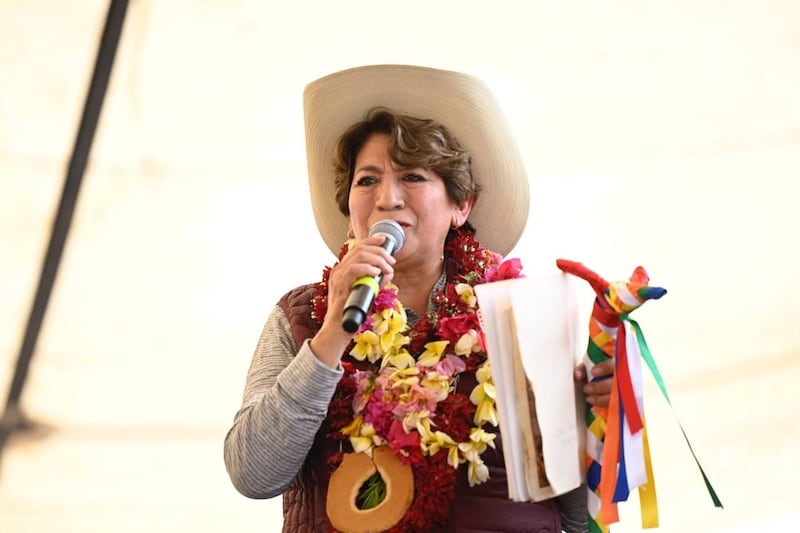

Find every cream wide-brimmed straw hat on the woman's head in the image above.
[303,65,530,255]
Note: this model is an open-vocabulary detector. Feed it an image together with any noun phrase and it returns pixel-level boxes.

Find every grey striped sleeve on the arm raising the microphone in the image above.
[224,306,343,498]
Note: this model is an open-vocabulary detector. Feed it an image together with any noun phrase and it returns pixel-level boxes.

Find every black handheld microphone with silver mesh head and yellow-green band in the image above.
[342,219,405,333]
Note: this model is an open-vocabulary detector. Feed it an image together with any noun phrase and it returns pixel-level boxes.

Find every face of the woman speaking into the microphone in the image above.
[348,134,472,261]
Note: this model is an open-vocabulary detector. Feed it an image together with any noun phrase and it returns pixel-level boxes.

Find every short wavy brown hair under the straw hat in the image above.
[334,107,480,216]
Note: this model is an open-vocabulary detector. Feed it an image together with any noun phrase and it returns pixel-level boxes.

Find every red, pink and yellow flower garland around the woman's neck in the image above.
[312,229,521,532]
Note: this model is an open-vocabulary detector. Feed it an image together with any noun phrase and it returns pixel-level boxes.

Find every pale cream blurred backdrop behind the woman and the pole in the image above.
[0,0,800,533]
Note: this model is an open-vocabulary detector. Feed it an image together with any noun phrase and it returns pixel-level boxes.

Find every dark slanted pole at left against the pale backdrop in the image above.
[0,0,128,454]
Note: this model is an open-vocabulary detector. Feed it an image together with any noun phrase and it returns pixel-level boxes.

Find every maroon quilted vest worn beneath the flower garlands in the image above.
[278,285,561,533]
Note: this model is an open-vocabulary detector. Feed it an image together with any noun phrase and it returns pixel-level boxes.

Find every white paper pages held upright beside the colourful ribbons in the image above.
[475,272,585,501]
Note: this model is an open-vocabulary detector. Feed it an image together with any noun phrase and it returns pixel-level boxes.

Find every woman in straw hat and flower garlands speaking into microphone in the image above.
[225,66,612,531]
